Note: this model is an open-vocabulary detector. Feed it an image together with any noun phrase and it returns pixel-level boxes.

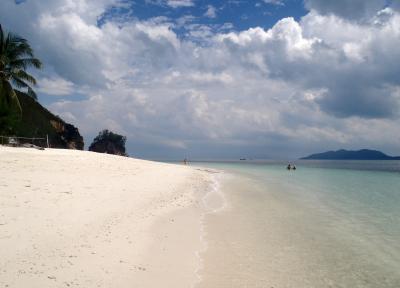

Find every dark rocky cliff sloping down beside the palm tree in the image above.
[14,93,84,150]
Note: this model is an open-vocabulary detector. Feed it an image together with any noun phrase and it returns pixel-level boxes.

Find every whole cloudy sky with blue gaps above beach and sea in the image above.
[0,0,400,159]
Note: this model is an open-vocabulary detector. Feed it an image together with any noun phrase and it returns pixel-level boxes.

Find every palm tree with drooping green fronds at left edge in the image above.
[0,24,42,130]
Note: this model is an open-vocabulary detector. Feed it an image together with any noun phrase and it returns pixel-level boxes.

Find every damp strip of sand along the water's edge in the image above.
[130,166,220,287]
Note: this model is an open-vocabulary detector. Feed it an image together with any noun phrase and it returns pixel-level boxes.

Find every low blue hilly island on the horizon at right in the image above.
[300,149,400,160]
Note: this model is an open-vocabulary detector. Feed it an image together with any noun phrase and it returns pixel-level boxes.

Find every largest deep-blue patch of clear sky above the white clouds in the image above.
[99,0,306,32]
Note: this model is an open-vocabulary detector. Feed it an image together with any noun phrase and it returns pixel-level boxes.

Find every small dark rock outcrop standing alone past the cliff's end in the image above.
[89,130,128,156]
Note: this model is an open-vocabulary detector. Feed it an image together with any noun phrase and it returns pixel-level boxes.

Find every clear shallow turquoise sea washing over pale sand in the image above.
[191,160,400,288]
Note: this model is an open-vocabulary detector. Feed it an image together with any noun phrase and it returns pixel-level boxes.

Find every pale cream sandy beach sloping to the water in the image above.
[0,146,212,288]
